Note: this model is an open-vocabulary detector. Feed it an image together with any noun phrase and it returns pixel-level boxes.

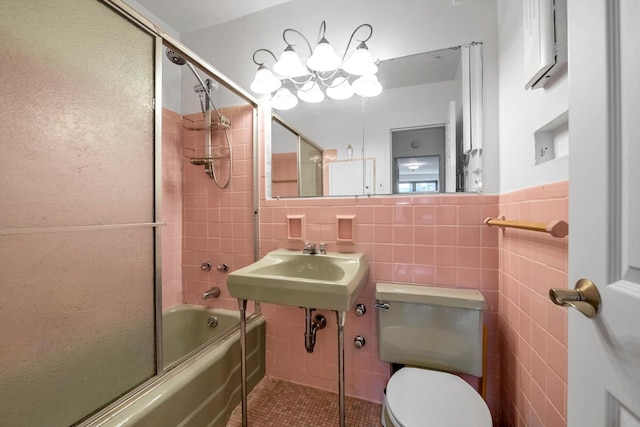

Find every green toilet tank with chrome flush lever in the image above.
[376,283,486,377]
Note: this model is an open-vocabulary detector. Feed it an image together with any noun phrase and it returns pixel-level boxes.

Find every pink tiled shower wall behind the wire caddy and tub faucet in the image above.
[182,105,253,310]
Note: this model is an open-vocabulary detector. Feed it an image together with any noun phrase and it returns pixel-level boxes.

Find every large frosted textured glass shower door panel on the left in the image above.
[0,0,156,426]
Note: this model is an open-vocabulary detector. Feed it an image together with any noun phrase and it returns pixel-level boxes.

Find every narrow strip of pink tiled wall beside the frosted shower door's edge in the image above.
[161,108,182,309]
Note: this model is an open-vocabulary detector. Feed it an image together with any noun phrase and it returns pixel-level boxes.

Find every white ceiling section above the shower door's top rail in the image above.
[133,0,289,34]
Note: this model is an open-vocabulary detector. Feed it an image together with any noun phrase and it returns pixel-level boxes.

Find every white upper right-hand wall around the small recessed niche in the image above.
[498,0,569,193]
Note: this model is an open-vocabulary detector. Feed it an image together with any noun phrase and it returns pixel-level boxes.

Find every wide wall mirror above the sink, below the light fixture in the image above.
[267,43,482,198]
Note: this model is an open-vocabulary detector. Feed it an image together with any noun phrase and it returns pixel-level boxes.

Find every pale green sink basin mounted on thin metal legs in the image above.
[227,249,369,311]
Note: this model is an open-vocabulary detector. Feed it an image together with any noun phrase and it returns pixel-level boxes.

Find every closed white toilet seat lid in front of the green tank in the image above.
[385,368,492,427]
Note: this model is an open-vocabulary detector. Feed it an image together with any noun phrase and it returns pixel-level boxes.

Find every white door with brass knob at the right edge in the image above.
[568,0,640,427]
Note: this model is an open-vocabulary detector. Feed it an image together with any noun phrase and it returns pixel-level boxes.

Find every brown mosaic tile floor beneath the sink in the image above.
[227,377,382,427]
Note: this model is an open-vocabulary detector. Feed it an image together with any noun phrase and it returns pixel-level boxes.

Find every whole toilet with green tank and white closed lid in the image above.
[376,283,492,427]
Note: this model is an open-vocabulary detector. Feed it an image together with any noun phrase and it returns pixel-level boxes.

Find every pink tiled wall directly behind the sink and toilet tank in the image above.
[260,195,499,414]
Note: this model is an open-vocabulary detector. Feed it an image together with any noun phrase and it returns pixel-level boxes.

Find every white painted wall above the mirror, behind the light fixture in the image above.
[181,0,499,193]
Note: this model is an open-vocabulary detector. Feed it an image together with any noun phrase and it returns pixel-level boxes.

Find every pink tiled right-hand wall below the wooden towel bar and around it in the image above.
[499,181,573,427]
